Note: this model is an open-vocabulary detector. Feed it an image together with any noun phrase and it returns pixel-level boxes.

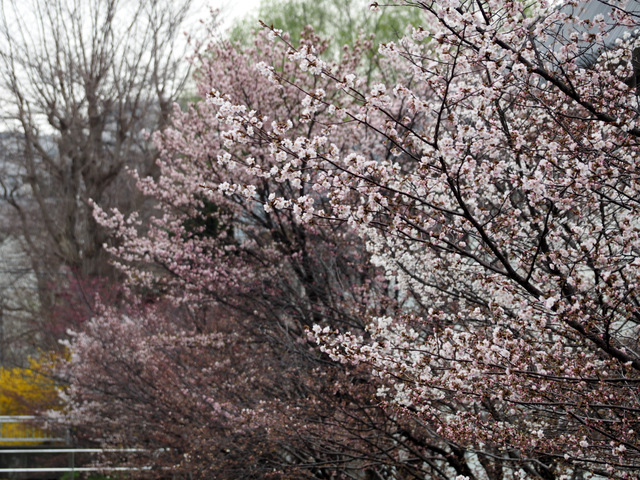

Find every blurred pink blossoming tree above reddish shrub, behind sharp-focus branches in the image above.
[93,28,384,329]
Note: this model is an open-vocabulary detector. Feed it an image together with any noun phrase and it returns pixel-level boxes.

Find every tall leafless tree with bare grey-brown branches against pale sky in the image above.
[0,0,198,352]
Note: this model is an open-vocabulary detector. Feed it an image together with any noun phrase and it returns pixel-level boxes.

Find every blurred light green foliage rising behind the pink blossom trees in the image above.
[229,0,421,55]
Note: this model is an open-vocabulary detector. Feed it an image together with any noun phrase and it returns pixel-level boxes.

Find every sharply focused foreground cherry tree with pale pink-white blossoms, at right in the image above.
[198,0,640,478]
